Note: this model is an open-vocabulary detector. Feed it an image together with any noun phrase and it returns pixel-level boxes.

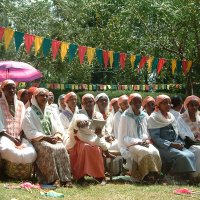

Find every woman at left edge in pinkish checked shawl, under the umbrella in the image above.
[0,80,37,179]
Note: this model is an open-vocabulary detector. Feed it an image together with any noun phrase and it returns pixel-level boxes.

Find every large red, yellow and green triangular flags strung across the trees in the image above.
[0,26,192,75]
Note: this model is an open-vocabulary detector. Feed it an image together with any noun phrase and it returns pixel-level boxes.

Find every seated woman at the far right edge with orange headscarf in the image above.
[177,95,200,179]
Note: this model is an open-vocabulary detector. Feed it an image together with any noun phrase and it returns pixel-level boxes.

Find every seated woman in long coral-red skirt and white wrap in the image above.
[67,94,105,184]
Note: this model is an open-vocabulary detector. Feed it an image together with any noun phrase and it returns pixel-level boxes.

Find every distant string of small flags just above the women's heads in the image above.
[18,82,185,92]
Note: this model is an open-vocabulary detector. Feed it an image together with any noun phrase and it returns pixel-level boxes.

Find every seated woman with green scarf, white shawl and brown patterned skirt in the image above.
[22,88,72,187]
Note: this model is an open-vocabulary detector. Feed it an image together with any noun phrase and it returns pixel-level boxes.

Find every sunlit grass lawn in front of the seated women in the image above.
[0,181,200,200]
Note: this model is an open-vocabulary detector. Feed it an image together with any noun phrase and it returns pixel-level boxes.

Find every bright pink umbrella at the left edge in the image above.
[0,61,42,82]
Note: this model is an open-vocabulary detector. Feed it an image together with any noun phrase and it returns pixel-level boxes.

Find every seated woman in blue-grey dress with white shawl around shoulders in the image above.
[148,95,196,178]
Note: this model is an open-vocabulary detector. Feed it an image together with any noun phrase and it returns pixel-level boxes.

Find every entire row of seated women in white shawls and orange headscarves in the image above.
[0,80,200,187]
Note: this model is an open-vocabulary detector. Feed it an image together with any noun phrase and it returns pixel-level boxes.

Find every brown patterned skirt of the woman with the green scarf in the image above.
[33,141,71,183]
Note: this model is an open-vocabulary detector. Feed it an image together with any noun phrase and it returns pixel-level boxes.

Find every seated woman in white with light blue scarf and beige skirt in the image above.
[118,93,161,182]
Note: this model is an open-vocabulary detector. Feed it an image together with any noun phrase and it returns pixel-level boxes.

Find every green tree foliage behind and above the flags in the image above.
[0,0,200,94]
